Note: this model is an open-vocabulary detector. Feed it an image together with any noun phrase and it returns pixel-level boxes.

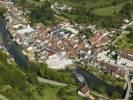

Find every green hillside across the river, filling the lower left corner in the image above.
[0,49,84,100]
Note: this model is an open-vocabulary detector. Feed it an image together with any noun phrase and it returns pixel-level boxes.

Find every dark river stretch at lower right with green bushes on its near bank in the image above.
[77,68,124,99]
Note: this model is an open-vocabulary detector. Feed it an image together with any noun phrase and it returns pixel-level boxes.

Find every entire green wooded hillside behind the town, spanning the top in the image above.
[12,0,133,28]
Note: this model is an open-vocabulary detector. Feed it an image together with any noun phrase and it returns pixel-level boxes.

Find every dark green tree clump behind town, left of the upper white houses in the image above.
[30,1,55,25]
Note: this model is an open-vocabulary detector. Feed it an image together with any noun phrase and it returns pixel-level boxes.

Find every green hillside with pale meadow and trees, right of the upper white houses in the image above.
[57,0,133,28]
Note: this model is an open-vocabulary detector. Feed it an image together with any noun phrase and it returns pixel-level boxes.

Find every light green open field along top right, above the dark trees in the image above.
[57,0,133,16]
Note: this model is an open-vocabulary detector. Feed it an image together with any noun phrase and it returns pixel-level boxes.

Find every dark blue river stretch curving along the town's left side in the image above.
[0,16,27,68]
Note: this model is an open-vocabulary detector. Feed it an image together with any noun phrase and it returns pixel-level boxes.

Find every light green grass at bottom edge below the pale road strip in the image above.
[34,85,84,100]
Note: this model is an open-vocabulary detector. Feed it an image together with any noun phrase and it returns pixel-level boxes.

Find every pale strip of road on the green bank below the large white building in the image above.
[37,76,67,86]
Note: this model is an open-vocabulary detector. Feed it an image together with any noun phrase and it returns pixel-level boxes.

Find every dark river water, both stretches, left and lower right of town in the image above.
[0,17,123,98]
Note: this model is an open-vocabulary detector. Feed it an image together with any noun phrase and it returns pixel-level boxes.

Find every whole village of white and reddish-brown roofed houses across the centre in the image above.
[0,0,133,99]
